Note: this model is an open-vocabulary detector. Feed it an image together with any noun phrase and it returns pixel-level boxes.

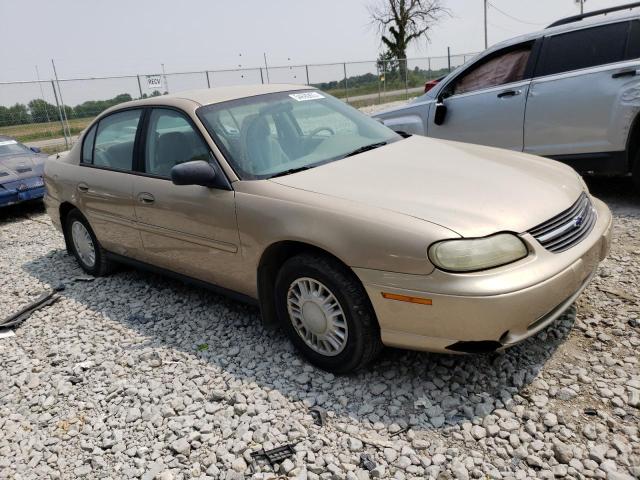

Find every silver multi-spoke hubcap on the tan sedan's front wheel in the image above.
[287,277,349,357]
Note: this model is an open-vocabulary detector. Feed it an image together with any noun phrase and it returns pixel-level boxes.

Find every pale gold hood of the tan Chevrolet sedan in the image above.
[271,136,583,237]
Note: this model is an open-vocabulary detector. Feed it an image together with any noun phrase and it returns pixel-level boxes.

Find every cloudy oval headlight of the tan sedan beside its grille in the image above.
[429,233,528,272]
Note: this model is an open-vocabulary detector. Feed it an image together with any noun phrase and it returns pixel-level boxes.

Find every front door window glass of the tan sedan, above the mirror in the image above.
[144,108,209,177]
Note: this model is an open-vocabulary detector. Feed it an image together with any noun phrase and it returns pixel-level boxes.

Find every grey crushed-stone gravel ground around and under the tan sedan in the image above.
[0,180,640,480]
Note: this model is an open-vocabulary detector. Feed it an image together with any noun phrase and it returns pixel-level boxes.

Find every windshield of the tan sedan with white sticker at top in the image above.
[197,90,401,180]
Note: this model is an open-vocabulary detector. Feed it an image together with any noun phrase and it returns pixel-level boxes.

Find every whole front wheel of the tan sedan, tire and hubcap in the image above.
[275,254,382,373]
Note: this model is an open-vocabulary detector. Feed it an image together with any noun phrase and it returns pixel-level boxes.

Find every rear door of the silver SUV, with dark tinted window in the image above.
[524,21,640,160]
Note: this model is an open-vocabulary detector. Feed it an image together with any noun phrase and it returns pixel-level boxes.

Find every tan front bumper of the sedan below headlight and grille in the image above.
[354,195,612,352]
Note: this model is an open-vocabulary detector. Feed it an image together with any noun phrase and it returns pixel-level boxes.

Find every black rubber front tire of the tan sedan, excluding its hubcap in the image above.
[275,253,383,373]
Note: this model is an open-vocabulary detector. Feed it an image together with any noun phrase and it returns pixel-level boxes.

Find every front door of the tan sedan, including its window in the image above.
[134,108,239,284]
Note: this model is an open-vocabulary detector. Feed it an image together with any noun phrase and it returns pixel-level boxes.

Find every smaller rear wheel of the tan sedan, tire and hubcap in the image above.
[65,209,112,277]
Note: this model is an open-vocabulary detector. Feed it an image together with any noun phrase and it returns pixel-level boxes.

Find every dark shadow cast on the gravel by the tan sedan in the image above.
[23,244,575,431]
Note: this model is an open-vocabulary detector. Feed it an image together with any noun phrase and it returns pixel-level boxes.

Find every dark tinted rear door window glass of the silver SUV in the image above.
[536,22,629,77]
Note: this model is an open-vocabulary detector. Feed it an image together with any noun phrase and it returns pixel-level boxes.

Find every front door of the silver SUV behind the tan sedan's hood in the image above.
[427,42,534,150]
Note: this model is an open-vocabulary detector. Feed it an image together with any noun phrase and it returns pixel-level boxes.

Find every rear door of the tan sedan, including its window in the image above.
[75,108,142,257]
